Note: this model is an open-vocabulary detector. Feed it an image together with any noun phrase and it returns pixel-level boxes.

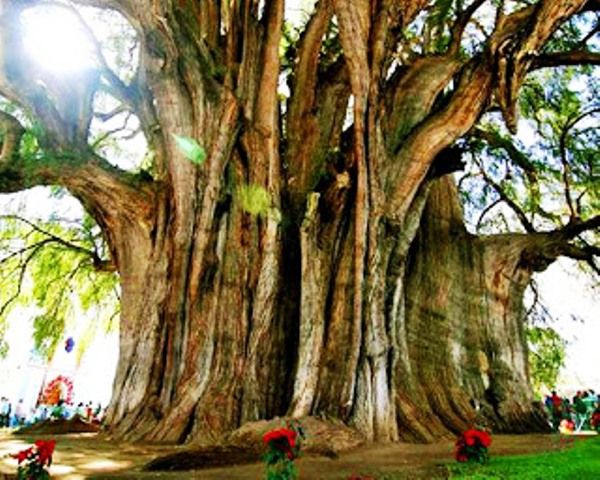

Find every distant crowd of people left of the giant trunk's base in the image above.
[0,396,106,428]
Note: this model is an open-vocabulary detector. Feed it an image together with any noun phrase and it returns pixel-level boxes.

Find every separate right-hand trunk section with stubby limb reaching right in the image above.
[406,177,553,438]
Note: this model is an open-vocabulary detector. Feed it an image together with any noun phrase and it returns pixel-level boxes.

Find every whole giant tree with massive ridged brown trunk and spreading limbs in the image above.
[0,0,600,441]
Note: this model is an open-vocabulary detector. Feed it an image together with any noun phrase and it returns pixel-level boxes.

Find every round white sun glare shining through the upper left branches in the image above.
[22,7,94,75]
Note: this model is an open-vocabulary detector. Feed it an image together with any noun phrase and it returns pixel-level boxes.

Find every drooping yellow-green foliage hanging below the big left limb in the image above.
[0,210,119,359]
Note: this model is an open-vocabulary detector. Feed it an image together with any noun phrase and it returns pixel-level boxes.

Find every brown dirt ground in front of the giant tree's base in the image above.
[0,430,573,480]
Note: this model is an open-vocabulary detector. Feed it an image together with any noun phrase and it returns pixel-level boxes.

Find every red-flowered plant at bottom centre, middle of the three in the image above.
[263,424,304,480]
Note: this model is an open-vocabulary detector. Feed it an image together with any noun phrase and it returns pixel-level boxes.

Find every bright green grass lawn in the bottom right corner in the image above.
[448,436,600,480]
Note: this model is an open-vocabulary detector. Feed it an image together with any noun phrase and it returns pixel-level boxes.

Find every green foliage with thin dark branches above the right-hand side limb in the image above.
[461,68,600,240]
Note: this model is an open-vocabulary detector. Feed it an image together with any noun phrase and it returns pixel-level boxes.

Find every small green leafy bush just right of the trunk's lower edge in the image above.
[526,326,566,393]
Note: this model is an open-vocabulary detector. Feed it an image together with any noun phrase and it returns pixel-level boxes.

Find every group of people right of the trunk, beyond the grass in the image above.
[544,389,600,432]
